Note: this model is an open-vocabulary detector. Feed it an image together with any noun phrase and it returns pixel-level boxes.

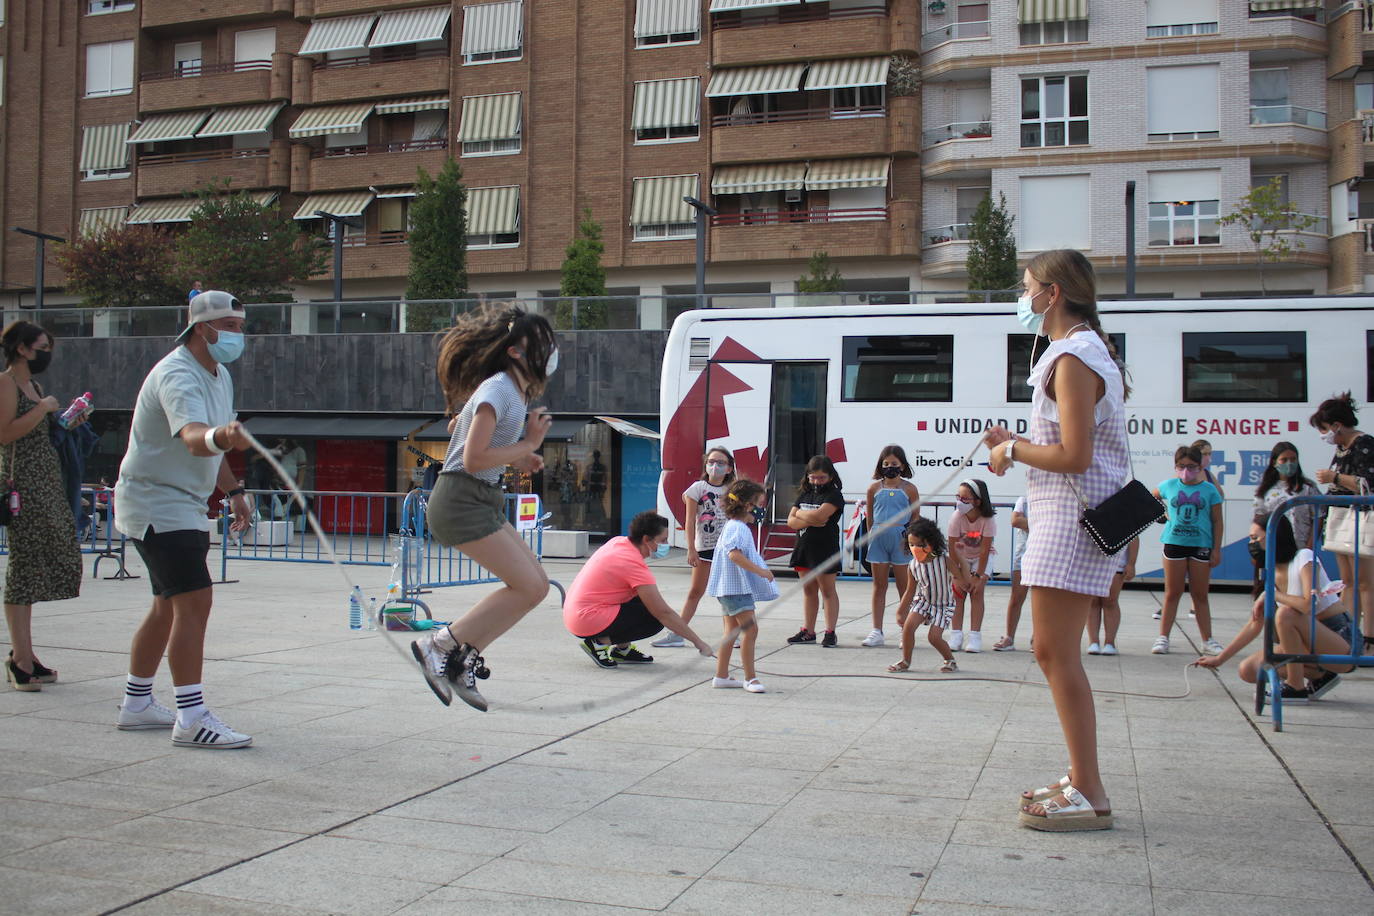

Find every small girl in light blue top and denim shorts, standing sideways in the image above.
[706,481,778,694]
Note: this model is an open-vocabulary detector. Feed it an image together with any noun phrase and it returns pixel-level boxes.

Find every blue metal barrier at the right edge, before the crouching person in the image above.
[1254,496,1374,732]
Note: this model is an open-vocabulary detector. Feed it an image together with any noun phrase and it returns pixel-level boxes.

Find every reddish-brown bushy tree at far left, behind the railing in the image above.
[56,224,190,309]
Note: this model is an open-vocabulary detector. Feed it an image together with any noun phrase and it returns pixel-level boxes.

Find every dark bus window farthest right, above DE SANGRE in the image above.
[1183,331,1307,404]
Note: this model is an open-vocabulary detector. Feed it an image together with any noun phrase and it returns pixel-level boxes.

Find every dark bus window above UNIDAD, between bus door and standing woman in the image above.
[842,334,954,401]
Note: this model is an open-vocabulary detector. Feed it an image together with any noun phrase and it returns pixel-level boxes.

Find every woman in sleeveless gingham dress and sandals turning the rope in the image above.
[985,250,1129,831]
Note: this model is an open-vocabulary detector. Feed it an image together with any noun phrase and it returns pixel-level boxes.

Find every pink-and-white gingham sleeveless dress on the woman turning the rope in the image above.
[1021,328,1131,596]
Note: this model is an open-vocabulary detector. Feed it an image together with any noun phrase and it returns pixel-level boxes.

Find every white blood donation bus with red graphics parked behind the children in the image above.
[658,297,1374,582]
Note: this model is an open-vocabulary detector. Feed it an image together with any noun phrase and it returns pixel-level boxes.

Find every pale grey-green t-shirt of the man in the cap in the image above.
[114,346,234,538]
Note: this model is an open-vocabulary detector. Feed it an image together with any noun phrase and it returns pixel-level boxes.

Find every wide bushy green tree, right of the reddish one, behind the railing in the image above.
[176,181,328,302]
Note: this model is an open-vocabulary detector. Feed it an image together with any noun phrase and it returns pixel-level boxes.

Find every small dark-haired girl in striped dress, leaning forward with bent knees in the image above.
[888,518,969,674]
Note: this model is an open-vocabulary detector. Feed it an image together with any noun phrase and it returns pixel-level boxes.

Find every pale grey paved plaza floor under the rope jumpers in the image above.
[0,551,1374,916]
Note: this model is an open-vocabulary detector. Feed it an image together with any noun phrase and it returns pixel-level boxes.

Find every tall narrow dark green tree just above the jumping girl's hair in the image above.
[405,159,467,331]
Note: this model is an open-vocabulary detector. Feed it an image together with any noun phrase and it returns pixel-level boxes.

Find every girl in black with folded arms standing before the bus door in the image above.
[787,455,845,648]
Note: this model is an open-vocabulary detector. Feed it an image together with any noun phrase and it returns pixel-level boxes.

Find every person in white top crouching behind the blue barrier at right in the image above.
[1194,516,1353,700]
